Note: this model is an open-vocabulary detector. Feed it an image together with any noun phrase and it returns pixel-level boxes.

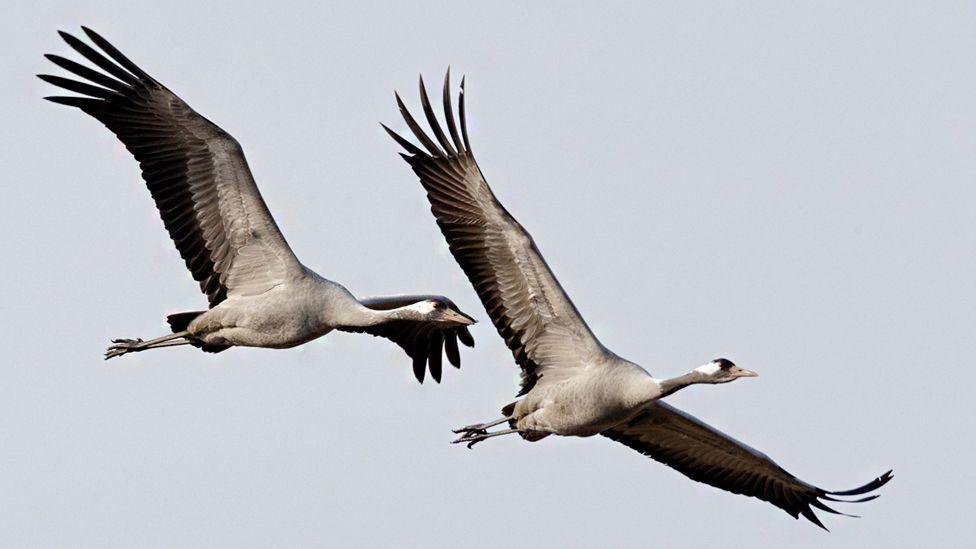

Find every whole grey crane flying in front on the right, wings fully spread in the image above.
[384,73,891,526]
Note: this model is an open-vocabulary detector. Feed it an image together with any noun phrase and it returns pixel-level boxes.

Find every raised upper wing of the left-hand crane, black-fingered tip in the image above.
[38,27,301,307]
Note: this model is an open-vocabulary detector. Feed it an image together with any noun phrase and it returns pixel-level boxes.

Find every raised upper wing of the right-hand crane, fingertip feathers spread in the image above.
[383,75,608,395]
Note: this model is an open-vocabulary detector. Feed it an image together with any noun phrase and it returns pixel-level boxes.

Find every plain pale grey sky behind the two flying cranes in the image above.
[0,1,976,548]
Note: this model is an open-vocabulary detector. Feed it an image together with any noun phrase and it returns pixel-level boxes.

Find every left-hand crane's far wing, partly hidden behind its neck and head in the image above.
[338,295,474,383]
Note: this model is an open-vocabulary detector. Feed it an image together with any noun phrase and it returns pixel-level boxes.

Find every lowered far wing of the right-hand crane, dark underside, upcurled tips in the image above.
[601,402,892,530]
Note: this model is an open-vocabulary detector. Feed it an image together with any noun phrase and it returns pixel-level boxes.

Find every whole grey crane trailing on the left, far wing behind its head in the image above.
[40,29,474,381]
